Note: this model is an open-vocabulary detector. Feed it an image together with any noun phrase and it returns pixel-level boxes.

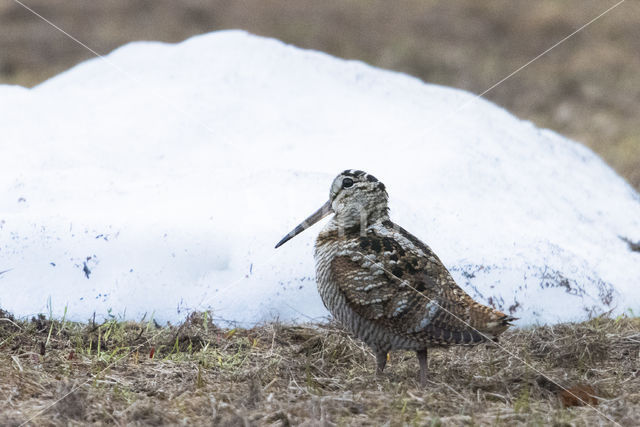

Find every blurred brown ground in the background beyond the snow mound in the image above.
[0,0,640,190]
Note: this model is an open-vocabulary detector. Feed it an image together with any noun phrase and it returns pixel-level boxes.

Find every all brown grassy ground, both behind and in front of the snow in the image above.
[0,0,640,426]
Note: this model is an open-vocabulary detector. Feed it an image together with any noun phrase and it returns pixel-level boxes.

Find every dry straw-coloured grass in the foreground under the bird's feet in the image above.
[0,313,640,426]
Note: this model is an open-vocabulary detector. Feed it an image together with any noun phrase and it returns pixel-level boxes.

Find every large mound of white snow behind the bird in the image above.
[0,31,640,326]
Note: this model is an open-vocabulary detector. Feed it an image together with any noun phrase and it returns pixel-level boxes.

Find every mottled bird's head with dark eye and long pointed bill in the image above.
[276,169,389,248]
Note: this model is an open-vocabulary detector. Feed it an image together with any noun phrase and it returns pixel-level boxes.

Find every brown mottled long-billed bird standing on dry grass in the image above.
[276,169,517,387]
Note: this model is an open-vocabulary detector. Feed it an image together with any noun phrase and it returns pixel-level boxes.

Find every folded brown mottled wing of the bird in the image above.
[331,223,511,344]
